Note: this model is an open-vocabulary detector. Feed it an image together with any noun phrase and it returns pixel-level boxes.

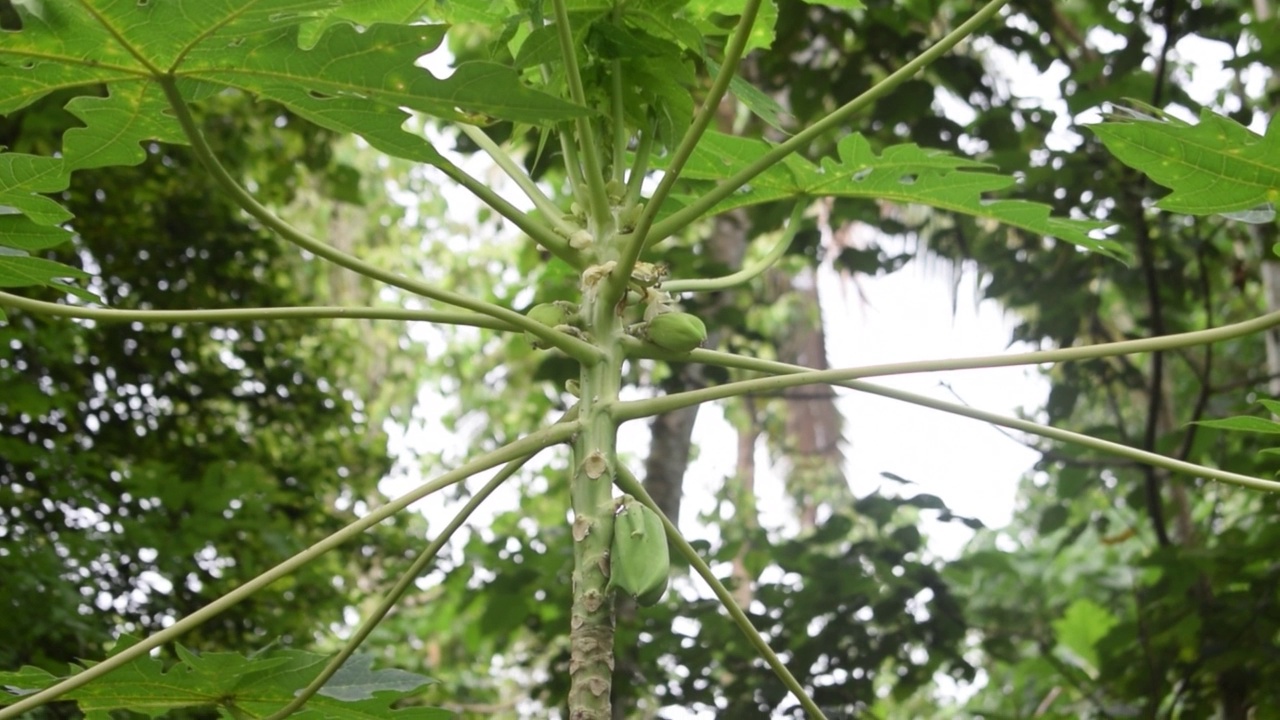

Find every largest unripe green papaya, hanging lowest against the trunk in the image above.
[609,495,671,606]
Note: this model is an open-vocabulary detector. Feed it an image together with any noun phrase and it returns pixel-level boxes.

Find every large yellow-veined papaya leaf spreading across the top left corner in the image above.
[0,0,588,124]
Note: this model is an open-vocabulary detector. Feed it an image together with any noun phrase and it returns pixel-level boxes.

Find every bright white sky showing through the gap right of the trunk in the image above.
[660,245,1048,556]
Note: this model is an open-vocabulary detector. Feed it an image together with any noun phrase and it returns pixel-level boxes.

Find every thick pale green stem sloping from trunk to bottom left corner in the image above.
[0,420,580,720]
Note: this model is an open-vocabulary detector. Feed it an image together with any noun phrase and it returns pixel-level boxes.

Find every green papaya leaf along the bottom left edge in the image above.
[0,637,454,720]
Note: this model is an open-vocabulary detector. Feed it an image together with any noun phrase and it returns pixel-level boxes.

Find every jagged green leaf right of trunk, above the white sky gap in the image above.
[665,132,1129,260]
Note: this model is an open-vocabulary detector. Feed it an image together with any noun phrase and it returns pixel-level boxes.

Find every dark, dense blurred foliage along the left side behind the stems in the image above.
[0,85,407,673]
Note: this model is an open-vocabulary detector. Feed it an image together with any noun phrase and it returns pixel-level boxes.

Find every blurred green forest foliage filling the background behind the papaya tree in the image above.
[0,0,1280,719]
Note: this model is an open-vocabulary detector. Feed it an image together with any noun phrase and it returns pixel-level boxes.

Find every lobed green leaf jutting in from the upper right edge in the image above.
[1089,99,1280,222]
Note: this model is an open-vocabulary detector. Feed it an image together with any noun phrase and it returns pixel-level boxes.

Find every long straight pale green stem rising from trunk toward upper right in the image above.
[636,0,1009,245]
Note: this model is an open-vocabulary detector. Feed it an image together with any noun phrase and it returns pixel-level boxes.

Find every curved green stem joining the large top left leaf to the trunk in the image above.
[160,77,600,365]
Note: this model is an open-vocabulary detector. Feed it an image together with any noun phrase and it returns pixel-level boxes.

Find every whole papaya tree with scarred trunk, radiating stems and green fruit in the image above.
[0,0,1280,720]
